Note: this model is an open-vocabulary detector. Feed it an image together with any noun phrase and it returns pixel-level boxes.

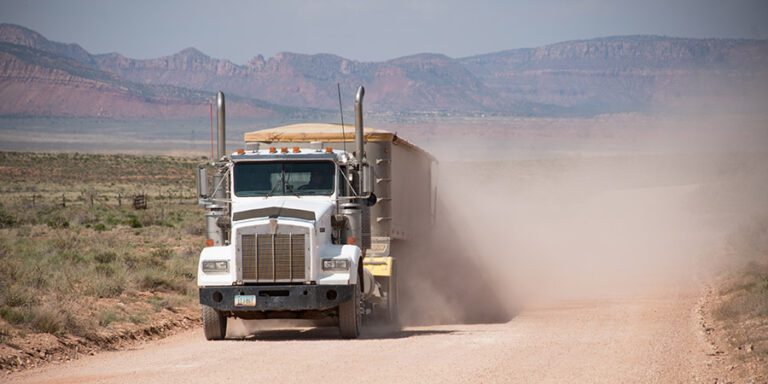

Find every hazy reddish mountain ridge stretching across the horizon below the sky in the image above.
[0,24,768,115]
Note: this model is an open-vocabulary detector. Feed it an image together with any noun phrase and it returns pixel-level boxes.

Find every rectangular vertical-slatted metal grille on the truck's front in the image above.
[240,234,306,282]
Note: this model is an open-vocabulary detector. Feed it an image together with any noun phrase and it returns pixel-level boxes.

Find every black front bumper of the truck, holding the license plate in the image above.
[200,285,355,312]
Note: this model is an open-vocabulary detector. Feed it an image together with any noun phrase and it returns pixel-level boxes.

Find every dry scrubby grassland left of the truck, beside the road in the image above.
[0,152,203,343]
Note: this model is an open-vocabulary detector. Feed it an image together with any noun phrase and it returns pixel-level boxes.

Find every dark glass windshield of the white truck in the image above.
[234,161,336,197]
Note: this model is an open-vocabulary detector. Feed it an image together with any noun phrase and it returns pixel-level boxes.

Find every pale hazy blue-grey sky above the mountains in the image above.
[0,0,768,64]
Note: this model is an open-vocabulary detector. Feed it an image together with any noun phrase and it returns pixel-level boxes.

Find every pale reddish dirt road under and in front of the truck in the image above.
[4,292,728,383]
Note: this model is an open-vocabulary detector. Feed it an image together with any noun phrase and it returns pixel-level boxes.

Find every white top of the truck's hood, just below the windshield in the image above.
[232,197,334,222]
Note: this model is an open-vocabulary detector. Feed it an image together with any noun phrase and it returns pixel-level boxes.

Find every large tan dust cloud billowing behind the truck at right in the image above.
[401,115,768,324]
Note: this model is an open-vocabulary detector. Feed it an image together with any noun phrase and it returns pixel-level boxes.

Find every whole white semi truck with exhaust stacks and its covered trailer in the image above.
[197,87,436,340]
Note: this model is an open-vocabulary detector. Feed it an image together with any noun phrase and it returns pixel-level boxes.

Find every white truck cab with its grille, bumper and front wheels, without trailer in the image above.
[198,147,371,339]
